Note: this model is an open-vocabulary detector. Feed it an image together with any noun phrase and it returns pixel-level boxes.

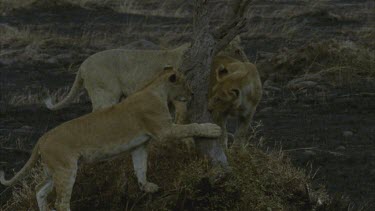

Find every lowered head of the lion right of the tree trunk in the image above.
[208,64,247,113]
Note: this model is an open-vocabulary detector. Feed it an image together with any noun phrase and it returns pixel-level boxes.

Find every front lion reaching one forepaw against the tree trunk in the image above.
[0,67,222,211]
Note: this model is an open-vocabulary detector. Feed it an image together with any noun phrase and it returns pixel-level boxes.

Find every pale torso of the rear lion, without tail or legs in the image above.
[80,49,186,95]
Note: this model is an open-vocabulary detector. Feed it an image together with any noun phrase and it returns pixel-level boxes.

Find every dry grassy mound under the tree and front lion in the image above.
[3,140,334,210]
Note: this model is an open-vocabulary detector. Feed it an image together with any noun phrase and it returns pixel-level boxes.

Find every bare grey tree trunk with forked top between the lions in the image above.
[180,0,251,167]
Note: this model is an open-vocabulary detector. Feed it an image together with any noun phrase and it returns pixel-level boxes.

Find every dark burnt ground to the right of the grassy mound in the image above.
[255,82,375,210]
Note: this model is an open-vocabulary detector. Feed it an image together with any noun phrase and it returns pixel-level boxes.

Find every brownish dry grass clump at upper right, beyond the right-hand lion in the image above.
[259,40,375,83]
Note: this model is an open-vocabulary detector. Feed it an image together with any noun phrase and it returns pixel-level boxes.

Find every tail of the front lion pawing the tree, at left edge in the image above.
[0,143,39,186]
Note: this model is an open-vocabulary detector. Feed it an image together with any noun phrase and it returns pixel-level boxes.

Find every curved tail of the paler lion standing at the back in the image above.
[44,70,83,110]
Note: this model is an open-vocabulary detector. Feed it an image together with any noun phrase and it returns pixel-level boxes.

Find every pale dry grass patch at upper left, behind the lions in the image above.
[0,24,108,65]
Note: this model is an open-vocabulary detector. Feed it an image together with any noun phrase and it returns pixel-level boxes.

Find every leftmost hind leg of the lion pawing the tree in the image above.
[35,169,53,211]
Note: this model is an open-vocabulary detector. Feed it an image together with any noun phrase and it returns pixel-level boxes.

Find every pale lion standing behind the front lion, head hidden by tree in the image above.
[45,44,190,111]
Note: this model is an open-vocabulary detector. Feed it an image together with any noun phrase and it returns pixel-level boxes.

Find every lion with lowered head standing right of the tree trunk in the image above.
[208,55,262,148]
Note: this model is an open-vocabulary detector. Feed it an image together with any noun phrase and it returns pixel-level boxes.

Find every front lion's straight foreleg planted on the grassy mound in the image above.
[131,145,159,192]
